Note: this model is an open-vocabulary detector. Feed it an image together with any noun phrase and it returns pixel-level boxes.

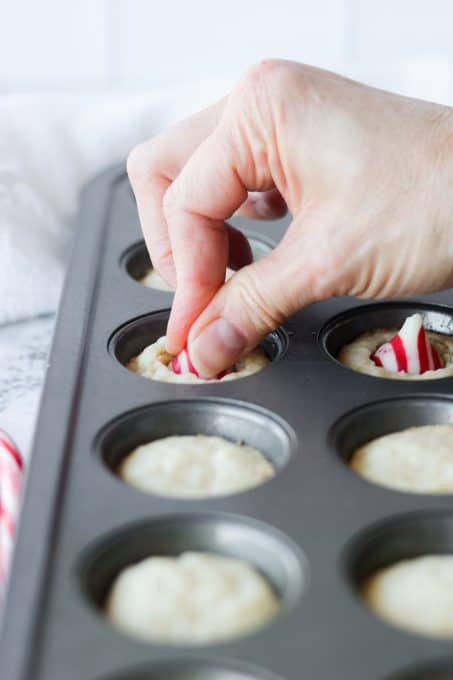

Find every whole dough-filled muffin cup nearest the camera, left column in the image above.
[80,513,306,645]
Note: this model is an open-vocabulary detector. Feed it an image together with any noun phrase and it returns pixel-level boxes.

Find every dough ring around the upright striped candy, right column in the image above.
[337,328,453,380]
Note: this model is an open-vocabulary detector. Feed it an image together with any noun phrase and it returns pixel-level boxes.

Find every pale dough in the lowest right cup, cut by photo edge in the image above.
[362,555,453,638]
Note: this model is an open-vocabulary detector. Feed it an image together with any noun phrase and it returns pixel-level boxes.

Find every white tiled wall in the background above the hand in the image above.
[0,0,453,103]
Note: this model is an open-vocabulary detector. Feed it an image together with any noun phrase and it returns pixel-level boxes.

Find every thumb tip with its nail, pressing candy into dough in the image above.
[190,319,247,378]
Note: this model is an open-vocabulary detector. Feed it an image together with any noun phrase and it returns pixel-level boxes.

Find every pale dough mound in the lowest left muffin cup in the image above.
[106,552,279,644]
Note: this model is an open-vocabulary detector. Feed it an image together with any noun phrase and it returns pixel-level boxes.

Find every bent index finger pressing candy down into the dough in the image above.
[164,117,272,354]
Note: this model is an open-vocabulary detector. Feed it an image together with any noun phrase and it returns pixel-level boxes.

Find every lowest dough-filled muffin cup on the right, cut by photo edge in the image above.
[346,511,453,639]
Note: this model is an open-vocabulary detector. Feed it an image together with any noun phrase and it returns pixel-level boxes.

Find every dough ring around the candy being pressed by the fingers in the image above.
[127,337,269,383]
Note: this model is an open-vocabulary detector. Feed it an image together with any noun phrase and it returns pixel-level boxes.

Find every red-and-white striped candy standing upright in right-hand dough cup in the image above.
[373,314,443,375]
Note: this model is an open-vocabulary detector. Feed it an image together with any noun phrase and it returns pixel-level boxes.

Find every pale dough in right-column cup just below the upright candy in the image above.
[350,425,453,494]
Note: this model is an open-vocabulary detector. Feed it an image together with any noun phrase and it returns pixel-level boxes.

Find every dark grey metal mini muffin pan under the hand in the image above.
[0,168,453,680]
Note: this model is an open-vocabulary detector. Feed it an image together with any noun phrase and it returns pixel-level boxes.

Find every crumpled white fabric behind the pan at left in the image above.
[0,81,229,324]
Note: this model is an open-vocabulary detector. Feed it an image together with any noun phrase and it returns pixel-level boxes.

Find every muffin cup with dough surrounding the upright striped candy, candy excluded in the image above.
[319,302,453,380]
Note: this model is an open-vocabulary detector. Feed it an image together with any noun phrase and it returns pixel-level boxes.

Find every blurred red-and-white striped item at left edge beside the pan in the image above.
[0,429,23,603]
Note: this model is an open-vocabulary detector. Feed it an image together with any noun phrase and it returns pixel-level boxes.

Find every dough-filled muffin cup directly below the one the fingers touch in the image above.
[96,399,296,499]
